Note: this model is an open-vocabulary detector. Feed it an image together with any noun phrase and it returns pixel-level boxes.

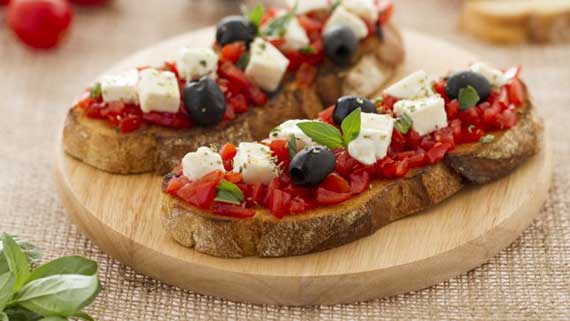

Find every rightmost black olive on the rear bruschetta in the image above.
[323,27,358,66]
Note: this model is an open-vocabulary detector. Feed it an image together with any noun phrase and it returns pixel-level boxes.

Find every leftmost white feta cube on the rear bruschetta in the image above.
[100,69,139,104]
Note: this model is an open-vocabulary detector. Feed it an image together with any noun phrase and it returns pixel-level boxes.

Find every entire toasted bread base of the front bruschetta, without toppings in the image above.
[162,84,542,258]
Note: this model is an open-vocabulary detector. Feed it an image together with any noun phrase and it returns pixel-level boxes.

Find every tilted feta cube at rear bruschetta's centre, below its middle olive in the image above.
[245,38,289,91]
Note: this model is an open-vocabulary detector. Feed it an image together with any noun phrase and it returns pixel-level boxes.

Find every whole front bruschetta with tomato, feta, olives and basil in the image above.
[161,63,541,258]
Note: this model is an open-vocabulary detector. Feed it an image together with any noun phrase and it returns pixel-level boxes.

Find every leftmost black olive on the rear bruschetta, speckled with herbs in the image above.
[184,77,226,126]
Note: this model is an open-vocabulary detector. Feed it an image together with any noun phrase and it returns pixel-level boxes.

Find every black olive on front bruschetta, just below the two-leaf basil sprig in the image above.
[289,146,336,187]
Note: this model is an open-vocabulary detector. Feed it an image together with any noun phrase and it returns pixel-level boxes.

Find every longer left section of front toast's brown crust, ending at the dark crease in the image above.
[162,163,463,258]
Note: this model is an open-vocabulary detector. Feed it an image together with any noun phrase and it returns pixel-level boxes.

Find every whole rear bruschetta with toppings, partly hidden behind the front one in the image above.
[63,0,404,174]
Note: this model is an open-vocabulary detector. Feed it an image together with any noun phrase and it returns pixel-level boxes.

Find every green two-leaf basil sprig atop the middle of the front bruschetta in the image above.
[297,108,361,149]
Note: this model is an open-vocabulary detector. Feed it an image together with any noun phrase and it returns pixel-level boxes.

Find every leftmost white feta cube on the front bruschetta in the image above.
[182,147,225,181]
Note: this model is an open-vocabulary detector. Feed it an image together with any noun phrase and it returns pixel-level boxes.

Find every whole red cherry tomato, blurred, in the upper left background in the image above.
[6,0,73,49]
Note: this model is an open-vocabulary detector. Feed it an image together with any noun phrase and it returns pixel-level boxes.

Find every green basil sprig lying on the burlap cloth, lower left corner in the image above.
[0,234,101,321]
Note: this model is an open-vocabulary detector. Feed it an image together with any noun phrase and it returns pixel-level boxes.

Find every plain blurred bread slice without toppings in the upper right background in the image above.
[460,0,570,44]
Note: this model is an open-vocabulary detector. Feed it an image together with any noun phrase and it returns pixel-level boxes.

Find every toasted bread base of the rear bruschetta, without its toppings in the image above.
[63,25,404,174]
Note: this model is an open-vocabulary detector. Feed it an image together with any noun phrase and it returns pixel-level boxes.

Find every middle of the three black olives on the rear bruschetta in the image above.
[216,16,257,47]
